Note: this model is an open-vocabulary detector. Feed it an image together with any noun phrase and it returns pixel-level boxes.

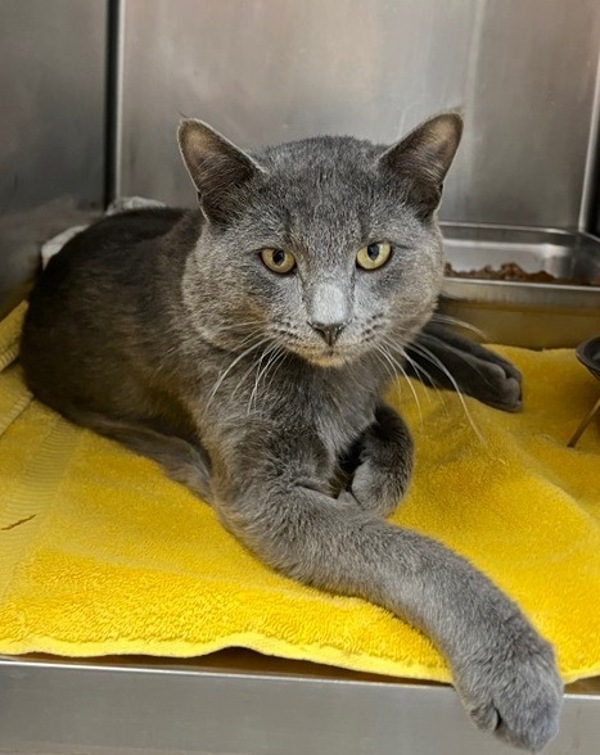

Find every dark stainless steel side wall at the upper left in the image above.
[0,0,107,316]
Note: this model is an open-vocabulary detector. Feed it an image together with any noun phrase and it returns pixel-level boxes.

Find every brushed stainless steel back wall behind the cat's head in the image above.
[117,0,600,227]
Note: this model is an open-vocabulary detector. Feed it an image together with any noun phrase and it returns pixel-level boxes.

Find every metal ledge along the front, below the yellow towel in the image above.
[0,650,600,755]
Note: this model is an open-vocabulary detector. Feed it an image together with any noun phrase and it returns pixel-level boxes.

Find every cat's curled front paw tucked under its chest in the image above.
[339,404,413,516]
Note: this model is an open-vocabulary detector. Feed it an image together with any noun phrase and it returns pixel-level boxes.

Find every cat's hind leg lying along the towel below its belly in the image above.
[65,409,211,503]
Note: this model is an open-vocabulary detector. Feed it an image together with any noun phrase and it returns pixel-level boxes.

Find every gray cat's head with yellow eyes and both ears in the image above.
[179,113,462,366]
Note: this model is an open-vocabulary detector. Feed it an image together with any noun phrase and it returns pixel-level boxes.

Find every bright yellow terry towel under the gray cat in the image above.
[0,307,600,681]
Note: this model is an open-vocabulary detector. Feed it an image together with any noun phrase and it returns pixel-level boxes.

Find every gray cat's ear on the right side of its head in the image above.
[379,113,463,215]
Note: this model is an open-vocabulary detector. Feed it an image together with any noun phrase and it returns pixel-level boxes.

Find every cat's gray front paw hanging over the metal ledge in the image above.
[454,622,563,752]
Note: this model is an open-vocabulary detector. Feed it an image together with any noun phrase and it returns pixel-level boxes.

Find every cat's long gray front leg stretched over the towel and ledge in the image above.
[213,432,562,751]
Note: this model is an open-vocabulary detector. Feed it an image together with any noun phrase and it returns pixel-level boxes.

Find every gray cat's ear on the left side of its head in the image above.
[177,118,264,223]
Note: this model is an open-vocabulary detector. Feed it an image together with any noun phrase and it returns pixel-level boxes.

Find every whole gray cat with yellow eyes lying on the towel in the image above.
[22,114,562,750]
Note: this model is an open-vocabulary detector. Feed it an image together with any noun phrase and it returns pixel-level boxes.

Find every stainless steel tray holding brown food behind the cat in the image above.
[441,223,600,348]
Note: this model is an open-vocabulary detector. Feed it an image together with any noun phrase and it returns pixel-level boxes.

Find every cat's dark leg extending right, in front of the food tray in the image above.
[405,322,522,412]
